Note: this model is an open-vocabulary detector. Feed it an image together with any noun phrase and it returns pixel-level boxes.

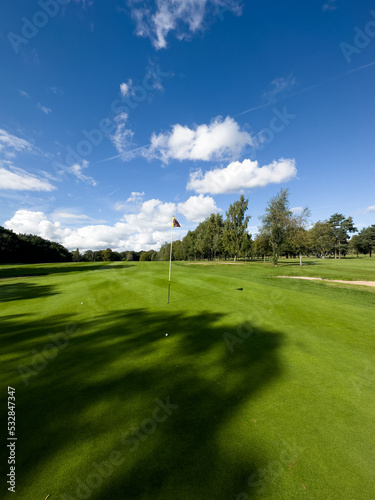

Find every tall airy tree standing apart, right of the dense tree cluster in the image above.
[261,189,292,267]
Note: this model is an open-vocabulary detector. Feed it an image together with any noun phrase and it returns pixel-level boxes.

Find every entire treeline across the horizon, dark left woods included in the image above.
[0,189,375,265]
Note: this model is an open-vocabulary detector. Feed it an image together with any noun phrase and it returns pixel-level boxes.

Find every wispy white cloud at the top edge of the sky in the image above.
[127,0,242,49]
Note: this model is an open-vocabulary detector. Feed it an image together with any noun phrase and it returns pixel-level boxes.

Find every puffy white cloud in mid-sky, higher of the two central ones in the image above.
[144,116,254,163]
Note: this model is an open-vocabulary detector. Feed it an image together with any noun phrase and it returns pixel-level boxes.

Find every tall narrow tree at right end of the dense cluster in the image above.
[223,195,250,262]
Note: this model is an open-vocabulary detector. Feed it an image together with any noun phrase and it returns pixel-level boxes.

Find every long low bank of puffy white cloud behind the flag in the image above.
[4,195,218,251]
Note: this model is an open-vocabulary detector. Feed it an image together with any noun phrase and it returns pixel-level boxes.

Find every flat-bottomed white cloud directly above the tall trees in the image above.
[187,158,297,194]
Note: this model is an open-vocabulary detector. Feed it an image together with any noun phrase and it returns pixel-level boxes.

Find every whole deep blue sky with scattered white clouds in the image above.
[0,0,375,250]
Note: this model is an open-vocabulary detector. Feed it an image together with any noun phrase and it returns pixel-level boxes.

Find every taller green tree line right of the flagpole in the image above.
[158,189,375,266]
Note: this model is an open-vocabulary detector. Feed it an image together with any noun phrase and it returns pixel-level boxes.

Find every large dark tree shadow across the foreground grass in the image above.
[3,309,283,500]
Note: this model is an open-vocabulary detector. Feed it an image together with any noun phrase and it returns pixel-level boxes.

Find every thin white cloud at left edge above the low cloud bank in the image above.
[0,166,56,191]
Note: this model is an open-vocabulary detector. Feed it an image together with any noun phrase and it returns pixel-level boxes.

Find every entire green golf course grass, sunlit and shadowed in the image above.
[0,258,375,500]
